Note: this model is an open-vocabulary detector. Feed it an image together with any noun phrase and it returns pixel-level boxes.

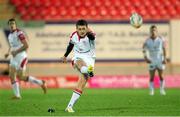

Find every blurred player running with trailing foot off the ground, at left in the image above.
[5,19,46,99]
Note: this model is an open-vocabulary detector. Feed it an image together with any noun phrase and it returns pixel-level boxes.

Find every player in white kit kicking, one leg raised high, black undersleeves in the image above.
[62,20,95,112]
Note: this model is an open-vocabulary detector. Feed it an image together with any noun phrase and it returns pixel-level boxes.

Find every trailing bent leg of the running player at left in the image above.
[17,58,47,93]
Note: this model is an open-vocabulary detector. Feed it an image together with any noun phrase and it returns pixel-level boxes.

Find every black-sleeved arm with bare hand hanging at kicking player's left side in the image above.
[61,41,74,63]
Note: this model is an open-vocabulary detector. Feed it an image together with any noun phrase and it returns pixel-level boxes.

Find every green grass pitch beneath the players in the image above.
[0,89,180,116]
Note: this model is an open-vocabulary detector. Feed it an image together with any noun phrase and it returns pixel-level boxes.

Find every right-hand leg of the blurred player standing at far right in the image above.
[158,69,166,95]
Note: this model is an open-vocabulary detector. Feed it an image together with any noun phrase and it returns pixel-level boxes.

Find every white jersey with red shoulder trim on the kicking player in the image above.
[70,31,95,57]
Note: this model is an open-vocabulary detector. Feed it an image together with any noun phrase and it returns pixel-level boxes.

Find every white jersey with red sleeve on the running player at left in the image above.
[8,29,25,52]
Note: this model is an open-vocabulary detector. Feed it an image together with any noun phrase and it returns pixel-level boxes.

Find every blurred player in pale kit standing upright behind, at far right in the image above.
[143,25,167,95]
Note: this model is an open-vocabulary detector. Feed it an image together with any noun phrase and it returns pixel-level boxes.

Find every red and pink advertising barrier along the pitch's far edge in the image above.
[0,75,180,89]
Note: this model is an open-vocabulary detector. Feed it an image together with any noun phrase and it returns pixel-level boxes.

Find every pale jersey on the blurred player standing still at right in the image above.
[144,36,166,61]
